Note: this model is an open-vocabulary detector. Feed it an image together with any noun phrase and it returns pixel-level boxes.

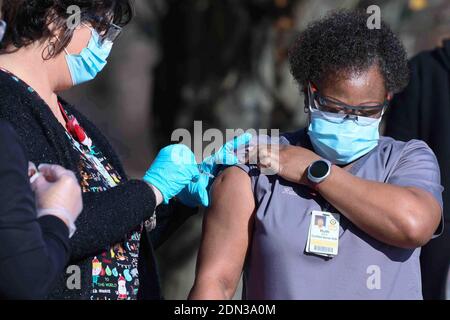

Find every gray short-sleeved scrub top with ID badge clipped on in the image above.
[238,130,443,300]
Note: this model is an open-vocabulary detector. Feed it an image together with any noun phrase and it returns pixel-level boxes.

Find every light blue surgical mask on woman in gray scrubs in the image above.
[308,108,381,165]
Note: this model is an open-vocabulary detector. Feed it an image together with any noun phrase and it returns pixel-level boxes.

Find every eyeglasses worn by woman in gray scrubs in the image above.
[308,84,389,119]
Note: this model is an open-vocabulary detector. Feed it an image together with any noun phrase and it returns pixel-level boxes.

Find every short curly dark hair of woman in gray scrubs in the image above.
[289,10,409,93]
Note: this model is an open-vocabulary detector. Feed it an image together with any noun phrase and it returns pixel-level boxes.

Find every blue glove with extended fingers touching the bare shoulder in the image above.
[177,133,252,207]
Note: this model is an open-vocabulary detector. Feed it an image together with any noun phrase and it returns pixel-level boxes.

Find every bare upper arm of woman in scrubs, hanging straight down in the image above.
[196,167,255,292]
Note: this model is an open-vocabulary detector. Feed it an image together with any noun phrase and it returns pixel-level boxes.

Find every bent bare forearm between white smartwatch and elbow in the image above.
[317,166,434,248]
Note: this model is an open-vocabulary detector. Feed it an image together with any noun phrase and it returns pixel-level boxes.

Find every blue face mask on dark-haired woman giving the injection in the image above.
[66,29,113,85]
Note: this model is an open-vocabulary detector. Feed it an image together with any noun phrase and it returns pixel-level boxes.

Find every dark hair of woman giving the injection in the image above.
[0,0,133,59]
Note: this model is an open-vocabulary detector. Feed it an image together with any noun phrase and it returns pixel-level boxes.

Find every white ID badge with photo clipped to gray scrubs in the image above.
[305,211,339,257]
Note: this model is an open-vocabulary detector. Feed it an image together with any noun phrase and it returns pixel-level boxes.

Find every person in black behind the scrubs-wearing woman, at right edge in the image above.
[386,38,450,299]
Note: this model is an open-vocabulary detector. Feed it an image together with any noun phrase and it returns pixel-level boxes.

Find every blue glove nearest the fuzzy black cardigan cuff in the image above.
[142,144,200,204]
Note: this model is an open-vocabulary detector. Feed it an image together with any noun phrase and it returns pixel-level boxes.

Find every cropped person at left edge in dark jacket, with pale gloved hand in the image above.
[0,10,82,299]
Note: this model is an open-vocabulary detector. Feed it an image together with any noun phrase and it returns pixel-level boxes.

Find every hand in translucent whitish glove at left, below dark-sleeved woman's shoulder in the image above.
[29,164,83,237]
